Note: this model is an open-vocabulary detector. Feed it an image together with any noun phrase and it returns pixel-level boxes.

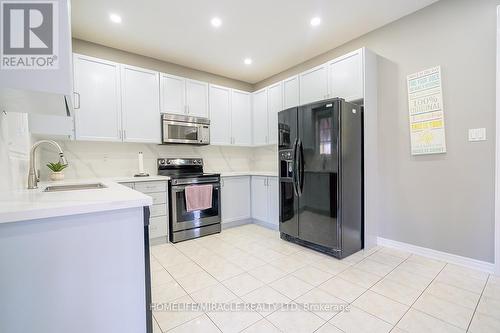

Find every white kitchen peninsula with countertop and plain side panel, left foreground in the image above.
[0,181,152,333]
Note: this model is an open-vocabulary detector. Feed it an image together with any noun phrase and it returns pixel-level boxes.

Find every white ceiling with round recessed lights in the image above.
[72,0,437,83]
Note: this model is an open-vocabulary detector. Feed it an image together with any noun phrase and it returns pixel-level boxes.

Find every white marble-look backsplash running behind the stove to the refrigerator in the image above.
[39,141,277,180]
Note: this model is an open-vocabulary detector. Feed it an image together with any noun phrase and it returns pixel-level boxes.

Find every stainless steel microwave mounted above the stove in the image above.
[161,114,210,145]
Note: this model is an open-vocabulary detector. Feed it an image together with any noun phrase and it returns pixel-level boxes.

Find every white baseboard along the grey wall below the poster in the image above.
[377,237,495,274]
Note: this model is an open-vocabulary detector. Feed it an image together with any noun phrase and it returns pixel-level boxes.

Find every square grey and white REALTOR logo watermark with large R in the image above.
[0,1,59,69]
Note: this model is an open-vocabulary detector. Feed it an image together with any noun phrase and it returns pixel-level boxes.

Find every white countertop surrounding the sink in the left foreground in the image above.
[0,178,153,223]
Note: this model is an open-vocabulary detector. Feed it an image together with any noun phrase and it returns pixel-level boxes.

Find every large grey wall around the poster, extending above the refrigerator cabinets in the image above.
[254,0,500,262]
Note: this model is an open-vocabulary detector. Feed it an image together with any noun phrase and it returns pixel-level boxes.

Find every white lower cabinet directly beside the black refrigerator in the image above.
[252,176,279,226]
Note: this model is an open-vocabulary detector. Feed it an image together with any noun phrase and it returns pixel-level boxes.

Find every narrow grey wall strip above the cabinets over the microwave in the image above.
[73,38,253,91]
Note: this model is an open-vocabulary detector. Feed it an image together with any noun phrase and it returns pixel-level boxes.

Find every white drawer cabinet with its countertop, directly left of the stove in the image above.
[121,181,168,242]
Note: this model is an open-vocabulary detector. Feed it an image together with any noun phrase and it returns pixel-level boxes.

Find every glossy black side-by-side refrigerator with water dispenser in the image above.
[278,98,364,258]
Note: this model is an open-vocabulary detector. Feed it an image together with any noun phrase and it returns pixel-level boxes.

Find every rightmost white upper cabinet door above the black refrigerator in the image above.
[329,52,363,101]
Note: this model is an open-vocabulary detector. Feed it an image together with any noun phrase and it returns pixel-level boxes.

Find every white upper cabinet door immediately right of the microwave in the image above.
[209,85,231,145]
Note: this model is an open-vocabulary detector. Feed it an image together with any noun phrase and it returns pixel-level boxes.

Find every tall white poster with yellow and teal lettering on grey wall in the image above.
[407,66,446,155]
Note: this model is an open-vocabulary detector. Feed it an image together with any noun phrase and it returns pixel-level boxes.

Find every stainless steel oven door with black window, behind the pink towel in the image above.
[170,181,221,232]
